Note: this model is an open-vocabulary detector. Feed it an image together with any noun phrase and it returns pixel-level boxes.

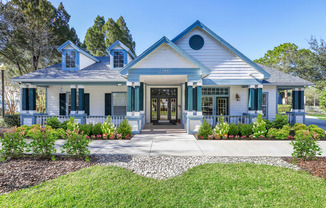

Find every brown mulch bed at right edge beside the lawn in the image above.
[282,157,326,180]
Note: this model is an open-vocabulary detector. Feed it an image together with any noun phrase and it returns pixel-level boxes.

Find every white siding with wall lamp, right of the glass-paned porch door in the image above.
[230,86,248,116]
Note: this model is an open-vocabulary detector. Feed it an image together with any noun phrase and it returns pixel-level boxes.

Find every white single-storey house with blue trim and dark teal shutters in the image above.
[13,21,313,133]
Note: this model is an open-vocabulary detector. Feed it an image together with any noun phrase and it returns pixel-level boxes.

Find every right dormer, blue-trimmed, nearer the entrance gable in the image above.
[106,40,136,70]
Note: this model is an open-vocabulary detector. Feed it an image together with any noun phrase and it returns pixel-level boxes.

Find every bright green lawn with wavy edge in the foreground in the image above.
[0,163,326,208]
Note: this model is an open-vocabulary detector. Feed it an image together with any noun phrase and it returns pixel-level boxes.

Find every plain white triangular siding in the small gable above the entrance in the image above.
[132,43,198,68]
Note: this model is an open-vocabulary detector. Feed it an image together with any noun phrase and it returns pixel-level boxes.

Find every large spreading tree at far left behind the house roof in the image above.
[0,0,80,74]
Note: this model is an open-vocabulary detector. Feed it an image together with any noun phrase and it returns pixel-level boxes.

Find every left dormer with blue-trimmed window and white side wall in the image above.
[58,40,99,70]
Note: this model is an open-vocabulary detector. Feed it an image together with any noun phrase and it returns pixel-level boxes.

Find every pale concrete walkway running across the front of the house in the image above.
[56,132,326,157]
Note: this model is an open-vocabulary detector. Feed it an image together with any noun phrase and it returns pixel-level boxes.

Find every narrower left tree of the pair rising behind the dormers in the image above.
[84,16,106,56]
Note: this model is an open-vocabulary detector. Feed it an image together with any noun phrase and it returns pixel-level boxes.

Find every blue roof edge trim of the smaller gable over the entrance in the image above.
[120,36,210,75]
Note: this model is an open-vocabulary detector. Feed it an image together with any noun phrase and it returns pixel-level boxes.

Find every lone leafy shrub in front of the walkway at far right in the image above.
[291,130,321,160]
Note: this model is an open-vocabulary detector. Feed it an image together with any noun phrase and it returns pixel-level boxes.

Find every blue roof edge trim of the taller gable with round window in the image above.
[172,20,270,79]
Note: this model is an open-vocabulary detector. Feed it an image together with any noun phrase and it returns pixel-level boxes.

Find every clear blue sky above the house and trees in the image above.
[50,0,326,60]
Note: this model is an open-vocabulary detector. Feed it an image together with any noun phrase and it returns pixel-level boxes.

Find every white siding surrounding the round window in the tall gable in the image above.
[176,27,263,79]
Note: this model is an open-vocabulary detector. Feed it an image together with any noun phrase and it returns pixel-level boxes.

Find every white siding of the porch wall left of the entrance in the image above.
[47,85,127,116]
